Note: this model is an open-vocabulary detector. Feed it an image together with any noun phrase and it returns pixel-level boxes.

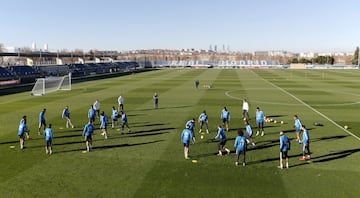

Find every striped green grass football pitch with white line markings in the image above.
[0,69,360,198]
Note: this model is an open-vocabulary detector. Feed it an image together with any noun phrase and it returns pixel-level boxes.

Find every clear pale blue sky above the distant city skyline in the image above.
[0,0,360,52]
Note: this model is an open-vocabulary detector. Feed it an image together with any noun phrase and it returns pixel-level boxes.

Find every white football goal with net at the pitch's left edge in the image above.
[31,73,71,96]
